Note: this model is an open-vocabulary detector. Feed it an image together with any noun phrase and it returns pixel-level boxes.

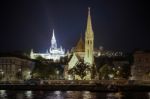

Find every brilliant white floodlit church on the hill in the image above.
[30,30,65,61]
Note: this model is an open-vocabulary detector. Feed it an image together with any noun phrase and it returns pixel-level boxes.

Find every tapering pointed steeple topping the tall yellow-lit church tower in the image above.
[85,7,93,36]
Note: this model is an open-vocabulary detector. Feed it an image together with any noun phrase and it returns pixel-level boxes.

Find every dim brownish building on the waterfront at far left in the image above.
[0,56,34,81]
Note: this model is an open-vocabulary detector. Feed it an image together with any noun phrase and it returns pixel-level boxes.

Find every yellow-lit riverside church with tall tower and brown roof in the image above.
[64,8,94,80]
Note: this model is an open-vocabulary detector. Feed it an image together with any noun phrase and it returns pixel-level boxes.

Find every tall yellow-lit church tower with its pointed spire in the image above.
[84,8,94,64]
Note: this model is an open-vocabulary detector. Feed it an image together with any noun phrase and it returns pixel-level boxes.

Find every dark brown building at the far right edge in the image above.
[131,51,150,80]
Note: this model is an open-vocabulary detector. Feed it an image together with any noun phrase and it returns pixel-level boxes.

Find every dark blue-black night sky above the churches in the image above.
[0,0,150,52]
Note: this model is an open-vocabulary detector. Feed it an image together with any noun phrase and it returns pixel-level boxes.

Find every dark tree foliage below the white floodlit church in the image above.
[32,57,63,79]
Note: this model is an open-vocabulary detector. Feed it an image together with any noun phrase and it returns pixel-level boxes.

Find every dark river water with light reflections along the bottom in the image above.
[0,90,150,99]
